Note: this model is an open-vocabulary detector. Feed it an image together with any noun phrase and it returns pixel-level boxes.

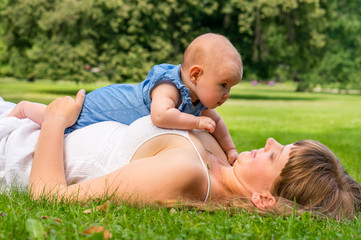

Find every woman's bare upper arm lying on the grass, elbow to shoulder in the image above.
[61,150,207,203]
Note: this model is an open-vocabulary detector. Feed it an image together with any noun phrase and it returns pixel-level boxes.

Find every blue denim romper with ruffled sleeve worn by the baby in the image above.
[65,63,207,133]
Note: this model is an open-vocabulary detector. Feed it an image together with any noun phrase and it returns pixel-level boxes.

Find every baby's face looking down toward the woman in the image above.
[196,62,241,109]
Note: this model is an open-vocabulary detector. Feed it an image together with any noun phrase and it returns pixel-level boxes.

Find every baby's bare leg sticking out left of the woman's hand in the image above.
[8,101,46,125]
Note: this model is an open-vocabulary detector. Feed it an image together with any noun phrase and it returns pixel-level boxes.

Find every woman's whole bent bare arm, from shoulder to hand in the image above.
[29,89,207,202]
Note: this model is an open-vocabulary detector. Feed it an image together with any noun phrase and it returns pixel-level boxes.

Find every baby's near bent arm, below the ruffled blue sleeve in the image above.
[150,83,216,132]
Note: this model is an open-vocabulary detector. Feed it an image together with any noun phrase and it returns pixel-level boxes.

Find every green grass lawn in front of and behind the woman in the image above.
[0,80,361,239]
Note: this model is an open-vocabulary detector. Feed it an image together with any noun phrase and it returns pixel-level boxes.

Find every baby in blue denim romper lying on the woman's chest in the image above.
[9,33,243,164]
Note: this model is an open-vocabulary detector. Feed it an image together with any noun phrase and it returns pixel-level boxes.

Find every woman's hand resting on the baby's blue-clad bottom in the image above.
[44,89,85,128]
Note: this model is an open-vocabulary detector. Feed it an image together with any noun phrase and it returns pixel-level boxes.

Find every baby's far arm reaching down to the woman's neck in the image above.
[202,109,238,165]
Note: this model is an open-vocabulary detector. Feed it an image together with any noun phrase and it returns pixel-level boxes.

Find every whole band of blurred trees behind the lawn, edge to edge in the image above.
[0,0,361,93]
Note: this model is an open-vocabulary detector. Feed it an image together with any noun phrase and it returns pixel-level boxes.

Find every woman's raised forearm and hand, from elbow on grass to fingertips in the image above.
[29,90,85,196]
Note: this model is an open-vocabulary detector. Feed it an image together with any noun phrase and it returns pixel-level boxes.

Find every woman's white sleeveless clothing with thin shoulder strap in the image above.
[0,98,210,201]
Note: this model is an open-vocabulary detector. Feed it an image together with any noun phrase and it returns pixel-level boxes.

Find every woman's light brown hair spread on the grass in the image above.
[271,140,361,219]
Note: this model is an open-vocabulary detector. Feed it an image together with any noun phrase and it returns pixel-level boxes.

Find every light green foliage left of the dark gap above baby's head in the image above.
[2,0,222,82]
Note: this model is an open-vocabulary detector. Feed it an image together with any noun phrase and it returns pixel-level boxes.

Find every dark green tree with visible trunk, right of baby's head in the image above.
[231,0,326,86]
